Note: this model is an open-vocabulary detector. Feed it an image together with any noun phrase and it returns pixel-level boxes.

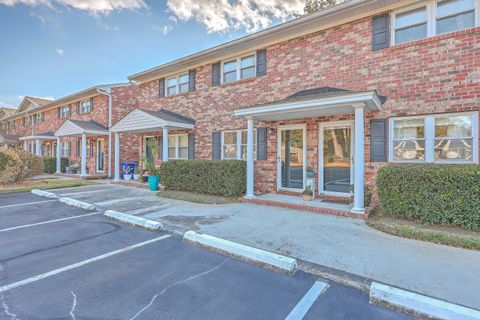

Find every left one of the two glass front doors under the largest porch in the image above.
[277,126,306,191]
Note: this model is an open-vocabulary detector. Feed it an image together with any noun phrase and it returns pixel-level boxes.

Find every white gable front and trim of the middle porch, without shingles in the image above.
[110,109,194,133]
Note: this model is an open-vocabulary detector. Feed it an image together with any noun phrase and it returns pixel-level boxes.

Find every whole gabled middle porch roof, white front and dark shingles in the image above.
[110,109,195,133]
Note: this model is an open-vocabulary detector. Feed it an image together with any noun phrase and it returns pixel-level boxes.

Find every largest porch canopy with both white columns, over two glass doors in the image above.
[235,87,386,213]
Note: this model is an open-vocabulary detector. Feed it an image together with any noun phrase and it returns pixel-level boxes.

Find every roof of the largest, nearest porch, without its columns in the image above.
[234,87,386,121]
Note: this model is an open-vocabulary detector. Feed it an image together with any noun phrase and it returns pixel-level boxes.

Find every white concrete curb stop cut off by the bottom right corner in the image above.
[370,282,480,320]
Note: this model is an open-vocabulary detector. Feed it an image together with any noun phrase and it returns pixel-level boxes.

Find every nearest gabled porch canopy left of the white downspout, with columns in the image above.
[55,120,109,177]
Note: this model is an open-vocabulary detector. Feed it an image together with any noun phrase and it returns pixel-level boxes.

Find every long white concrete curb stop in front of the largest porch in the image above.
[183,230,297,274]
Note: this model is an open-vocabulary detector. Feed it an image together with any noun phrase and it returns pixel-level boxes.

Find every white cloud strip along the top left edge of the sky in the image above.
[0,0,146,14]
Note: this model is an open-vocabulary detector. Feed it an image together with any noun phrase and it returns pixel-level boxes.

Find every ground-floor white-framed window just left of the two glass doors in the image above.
[221,130,257,160]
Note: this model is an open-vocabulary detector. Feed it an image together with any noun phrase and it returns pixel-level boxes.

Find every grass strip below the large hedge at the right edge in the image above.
[366,212,480,251]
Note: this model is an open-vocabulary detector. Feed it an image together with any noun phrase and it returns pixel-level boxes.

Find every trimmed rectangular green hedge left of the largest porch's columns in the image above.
[160,160,247,197]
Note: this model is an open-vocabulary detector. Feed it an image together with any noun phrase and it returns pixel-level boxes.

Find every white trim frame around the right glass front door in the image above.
[318,120,355,196]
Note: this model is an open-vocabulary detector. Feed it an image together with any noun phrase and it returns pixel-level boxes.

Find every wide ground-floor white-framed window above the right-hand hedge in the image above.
[390,112,478,163]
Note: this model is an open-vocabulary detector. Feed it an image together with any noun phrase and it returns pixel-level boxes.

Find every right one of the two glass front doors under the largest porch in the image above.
[319,121,353,194]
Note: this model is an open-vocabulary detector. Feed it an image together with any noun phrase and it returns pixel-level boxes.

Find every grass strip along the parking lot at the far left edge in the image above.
[0,178,95,194]
